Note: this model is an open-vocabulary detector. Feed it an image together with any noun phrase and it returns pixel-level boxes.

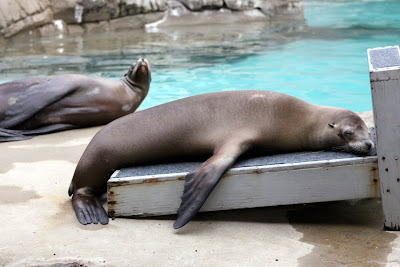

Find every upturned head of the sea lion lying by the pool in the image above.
[125,58,151,90]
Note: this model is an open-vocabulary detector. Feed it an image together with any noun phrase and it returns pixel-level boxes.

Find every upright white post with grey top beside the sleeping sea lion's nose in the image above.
[368,46,400,230]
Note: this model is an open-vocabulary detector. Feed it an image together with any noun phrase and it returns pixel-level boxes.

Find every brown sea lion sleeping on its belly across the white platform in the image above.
[68,90,374,228]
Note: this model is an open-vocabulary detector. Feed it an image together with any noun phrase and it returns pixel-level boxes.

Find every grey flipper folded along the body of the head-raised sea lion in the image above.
[0,77,77,129]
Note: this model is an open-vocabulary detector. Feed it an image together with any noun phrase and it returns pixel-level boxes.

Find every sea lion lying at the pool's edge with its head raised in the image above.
[0,58,151,141]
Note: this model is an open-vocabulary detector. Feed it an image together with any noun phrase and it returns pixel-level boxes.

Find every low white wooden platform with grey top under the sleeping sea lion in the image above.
[108,142,379,217]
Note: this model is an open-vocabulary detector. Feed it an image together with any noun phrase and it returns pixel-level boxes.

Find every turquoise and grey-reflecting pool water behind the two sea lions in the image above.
[0,0,400,111]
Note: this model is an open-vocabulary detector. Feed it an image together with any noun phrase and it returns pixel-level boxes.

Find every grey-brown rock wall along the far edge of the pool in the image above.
[0,0,303,38]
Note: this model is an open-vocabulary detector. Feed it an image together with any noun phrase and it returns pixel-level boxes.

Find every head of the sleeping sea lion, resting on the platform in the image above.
[325,109,374,155]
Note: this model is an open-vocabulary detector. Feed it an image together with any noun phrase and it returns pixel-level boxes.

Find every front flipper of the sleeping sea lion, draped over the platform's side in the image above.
[174,138,249,229]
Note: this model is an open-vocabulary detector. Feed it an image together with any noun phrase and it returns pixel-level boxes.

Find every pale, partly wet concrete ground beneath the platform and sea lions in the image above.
[0,113,400,266]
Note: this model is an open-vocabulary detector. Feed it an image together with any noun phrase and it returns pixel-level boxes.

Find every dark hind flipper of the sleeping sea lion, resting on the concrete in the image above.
[68,184,108,225]
